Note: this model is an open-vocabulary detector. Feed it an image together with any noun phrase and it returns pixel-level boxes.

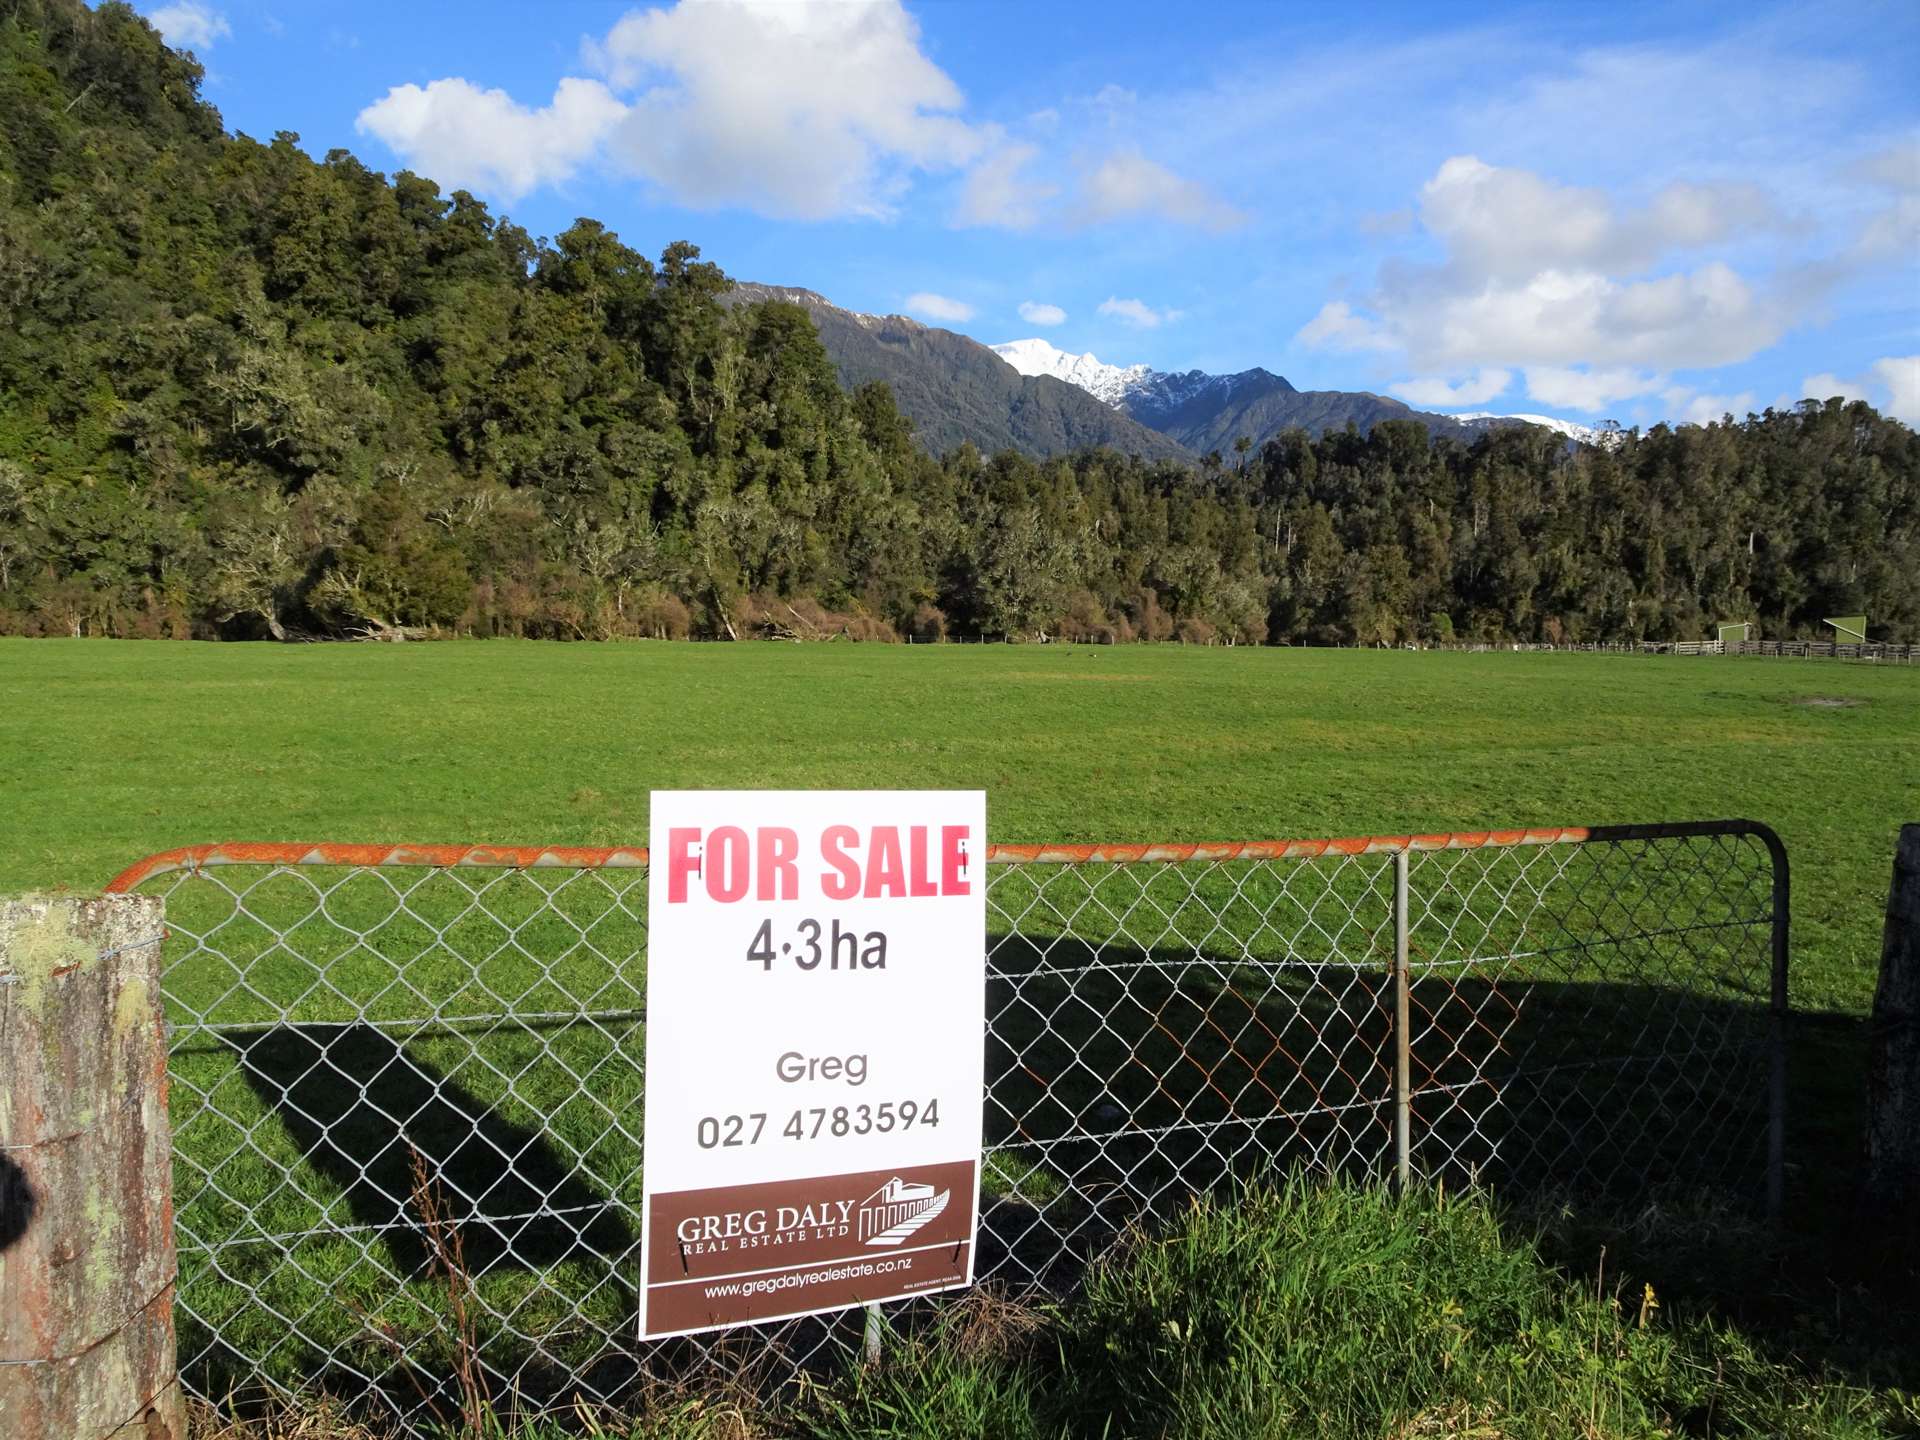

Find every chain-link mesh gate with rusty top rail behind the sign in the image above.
[113,822,1788,1421]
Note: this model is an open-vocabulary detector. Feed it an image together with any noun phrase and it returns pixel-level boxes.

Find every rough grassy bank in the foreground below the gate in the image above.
[191,1183,1920,1440]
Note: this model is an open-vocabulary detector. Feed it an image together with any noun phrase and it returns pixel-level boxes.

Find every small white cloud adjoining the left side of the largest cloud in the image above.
[353,79,626,200]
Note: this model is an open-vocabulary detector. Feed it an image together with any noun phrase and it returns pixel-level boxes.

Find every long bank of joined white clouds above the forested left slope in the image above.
[353,0,1248,230]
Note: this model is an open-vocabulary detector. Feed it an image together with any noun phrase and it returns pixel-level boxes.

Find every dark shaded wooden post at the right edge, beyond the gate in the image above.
[1866,826,1920,1223]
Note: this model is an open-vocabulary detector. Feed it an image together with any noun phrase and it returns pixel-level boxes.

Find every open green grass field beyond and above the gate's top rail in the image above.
[0,641,1920,1016]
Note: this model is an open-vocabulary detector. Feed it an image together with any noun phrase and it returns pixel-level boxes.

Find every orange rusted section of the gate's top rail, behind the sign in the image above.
[108,826,1620,895]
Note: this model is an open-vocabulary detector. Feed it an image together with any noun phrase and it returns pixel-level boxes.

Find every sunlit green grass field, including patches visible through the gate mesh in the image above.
[0,641,1920,1440]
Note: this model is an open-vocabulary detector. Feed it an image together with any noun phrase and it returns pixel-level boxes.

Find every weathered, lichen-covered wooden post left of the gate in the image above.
[0,895,186,1440]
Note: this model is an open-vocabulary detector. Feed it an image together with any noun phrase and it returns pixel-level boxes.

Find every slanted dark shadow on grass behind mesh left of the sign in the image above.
[228,1025,636,1275]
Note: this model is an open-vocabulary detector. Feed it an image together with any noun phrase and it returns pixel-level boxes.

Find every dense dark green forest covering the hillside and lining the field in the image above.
[0,0,1920,643]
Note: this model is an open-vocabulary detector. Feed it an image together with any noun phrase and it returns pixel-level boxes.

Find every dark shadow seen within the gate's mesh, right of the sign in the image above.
[981,937,1770,1288]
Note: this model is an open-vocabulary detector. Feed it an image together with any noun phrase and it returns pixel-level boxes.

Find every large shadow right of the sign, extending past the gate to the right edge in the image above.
[981,941,1920,1390]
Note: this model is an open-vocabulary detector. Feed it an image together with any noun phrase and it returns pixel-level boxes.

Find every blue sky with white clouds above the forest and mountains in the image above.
[142,0,1920,424]
